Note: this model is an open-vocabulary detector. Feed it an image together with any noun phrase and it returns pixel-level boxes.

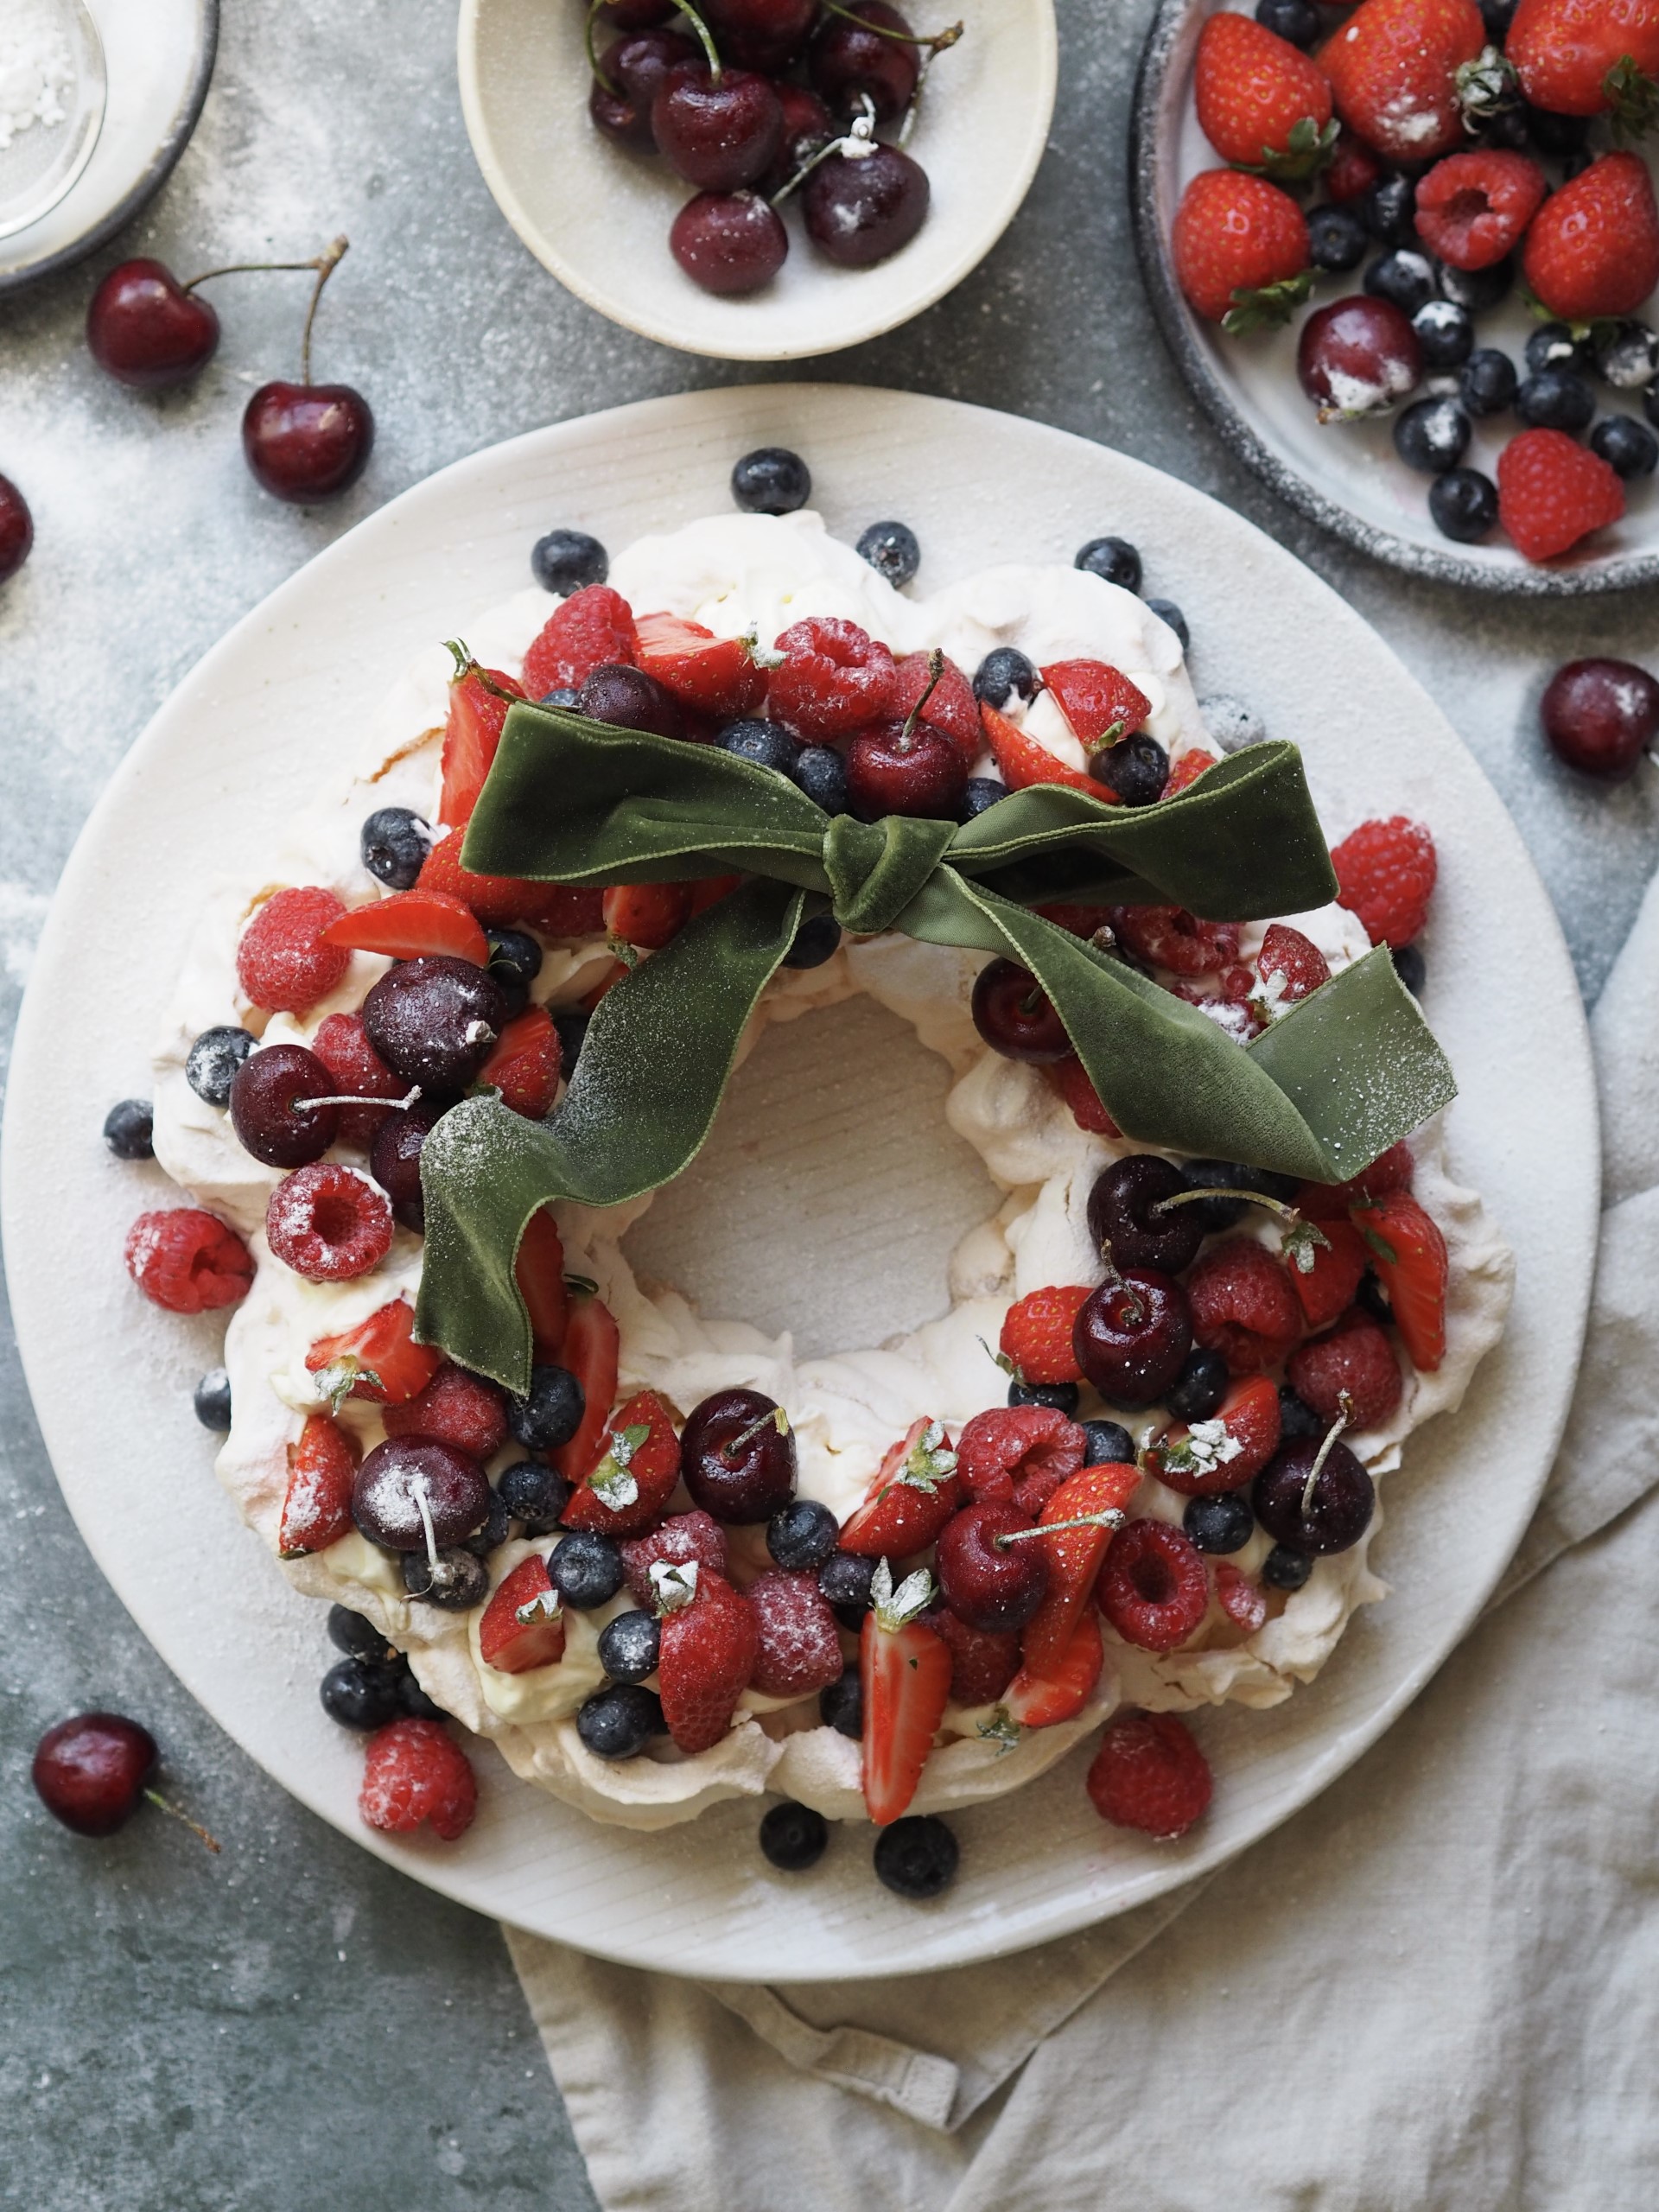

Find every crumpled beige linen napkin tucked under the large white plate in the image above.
[506,885,1659,2212]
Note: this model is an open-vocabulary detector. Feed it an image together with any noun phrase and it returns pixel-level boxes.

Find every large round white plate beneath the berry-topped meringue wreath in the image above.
[0,385,1597,1980]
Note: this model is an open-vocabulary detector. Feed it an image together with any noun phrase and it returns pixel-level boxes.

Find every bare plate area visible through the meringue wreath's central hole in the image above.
[621,995,1002,1362]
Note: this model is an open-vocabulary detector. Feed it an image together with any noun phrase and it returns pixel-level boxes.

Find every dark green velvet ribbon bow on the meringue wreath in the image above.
[418,706,1455,1391]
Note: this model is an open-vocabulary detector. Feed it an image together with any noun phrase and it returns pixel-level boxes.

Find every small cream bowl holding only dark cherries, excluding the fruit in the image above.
[460,0,1058,360]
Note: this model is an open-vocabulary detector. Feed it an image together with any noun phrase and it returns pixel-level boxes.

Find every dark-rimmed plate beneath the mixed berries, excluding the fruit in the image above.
[1130,0,1659,597]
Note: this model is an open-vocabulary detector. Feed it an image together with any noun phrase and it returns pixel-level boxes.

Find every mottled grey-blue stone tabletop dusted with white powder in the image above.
[0,0,1659,2212]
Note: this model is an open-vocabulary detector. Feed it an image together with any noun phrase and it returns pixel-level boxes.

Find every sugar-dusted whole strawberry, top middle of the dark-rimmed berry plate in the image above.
[1319,0,1486,162]
